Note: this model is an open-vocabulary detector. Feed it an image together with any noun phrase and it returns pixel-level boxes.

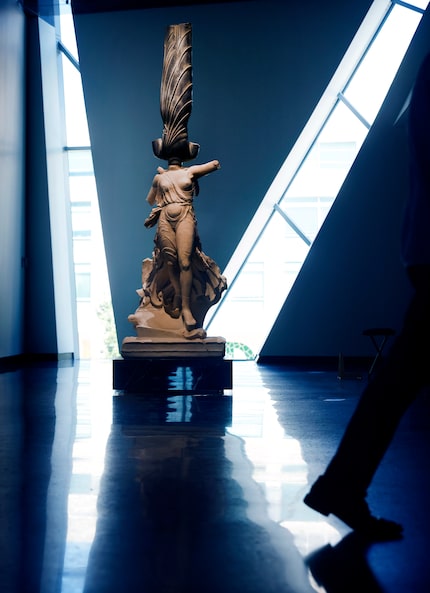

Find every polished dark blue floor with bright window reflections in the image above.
[0,361,430,593]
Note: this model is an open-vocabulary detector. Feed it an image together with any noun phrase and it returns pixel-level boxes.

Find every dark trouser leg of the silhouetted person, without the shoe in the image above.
[324,266,430,497]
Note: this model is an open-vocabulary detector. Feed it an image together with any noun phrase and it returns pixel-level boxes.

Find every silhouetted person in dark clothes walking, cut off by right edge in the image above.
[304,54,430,540]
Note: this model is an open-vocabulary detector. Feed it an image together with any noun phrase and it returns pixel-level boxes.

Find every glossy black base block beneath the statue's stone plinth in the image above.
[113,357,233,395]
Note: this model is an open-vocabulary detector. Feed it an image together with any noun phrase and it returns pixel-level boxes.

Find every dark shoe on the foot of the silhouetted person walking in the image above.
[303,476,403,541]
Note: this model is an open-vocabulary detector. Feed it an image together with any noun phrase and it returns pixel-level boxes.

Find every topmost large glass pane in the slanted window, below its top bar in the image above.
[344,5,422,124]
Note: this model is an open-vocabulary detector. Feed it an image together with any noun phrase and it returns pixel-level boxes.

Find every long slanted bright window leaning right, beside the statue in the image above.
[207,0,428,359]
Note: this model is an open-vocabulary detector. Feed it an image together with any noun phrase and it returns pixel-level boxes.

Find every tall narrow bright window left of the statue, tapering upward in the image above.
[59,6,118,359]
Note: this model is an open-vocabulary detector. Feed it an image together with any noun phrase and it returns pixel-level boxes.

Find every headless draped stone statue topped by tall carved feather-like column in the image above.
[123,23,227,356]
